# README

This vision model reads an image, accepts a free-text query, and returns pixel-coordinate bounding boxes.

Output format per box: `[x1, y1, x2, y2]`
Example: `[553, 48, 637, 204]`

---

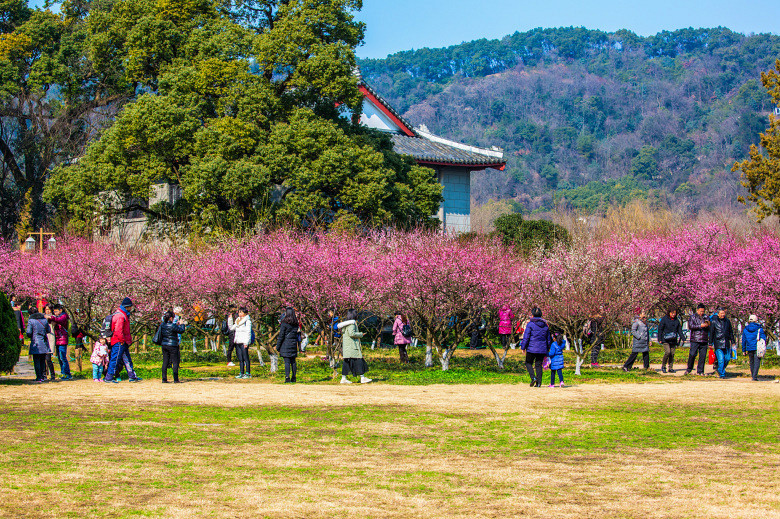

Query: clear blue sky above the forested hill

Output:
[357, 0, 780, 58]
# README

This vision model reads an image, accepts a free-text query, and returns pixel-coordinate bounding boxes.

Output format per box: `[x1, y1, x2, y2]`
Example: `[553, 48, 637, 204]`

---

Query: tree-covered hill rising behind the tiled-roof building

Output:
[360, 27, 780, 210]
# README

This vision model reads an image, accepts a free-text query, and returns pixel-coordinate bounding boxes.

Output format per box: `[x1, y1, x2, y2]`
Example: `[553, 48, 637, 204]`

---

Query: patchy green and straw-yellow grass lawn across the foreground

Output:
[0, 376, 780, 519]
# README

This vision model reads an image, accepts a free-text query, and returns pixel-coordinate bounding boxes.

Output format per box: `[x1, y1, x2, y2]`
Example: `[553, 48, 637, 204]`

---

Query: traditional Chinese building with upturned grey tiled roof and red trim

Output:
[360, 79, 506, 232]
